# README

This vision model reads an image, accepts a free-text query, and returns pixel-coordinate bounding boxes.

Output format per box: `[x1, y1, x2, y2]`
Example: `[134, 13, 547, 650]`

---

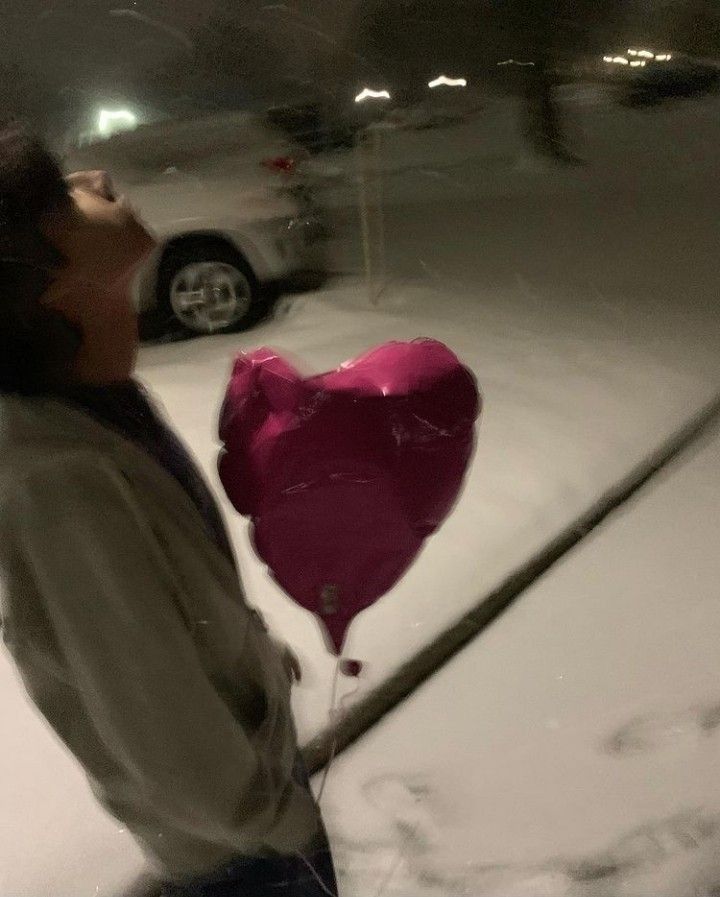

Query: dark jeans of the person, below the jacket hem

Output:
[162, 758, 337, 897]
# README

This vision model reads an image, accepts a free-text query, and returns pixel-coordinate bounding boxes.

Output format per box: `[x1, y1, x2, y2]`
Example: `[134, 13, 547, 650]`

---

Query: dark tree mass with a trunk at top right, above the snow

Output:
[353, 0, 720, 162]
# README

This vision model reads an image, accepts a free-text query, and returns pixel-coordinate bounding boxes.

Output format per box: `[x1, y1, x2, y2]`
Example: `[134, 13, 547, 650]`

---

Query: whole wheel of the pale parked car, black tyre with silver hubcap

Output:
[158, 240, 260, 335]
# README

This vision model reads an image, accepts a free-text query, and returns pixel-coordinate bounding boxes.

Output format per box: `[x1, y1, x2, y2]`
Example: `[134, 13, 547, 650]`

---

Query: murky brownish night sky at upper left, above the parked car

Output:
[0, 0, 362, 133]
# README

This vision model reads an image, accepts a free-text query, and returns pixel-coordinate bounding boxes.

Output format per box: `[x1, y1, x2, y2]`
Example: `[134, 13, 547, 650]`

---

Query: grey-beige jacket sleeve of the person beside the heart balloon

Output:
[7, 453, 317, 852]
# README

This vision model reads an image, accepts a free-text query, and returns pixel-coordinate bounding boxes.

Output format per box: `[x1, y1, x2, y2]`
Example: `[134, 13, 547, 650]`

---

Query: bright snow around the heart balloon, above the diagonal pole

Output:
[135, 260, 720, 740]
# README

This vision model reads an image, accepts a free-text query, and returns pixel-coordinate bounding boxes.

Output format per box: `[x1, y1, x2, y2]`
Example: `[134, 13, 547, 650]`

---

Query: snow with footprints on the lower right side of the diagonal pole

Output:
[322, 422, 720, 897]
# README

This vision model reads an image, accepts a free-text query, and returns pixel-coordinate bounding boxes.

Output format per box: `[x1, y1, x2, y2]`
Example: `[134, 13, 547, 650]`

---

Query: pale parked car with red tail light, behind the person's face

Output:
[65, 113, 326, 334]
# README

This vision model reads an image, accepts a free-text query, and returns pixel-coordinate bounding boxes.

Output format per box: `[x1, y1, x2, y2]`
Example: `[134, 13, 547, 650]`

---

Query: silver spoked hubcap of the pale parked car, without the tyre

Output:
[170, 262, 252, 333]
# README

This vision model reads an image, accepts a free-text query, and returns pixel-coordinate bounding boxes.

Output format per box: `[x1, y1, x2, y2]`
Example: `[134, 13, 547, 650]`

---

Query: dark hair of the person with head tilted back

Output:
[0, 124, 81, 395]
